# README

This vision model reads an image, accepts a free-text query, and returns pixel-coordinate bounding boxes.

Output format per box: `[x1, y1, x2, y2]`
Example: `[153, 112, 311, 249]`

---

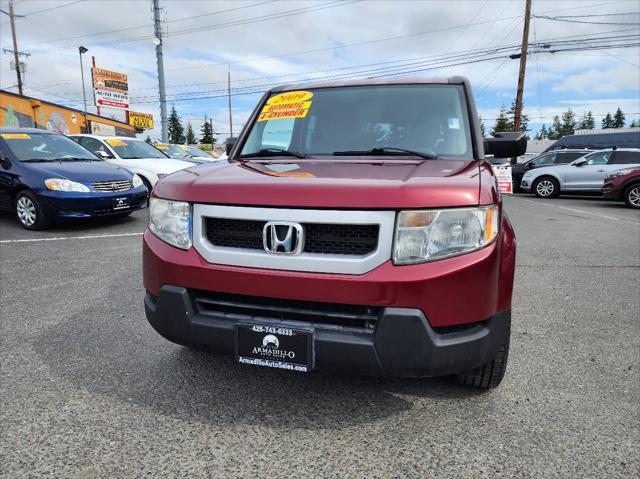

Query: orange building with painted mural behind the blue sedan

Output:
[0, 90, 144, 137]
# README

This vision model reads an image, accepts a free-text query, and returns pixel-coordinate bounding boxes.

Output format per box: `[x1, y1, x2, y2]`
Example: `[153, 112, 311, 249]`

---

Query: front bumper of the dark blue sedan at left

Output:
[38, 187, 148, 220]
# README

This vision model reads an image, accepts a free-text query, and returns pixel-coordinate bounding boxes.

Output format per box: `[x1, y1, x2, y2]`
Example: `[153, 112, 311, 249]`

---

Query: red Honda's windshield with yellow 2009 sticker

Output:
[240, 85, 473, 159]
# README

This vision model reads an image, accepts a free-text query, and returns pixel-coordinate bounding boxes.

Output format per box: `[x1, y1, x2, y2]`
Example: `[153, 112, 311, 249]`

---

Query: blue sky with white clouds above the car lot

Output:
[0, 0, 640, 137]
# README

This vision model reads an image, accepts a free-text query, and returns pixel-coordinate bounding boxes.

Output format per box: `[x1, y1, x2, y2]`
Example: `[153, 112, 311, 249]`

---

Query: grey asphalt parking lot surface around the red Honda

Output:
[0, 195, 640, 478]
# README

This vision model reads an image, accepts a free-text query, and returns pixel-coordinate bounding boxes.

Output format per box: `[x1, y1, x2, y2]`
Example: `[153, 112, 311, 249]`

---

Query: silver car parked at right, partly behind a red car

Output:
[520, 148, 640, 198]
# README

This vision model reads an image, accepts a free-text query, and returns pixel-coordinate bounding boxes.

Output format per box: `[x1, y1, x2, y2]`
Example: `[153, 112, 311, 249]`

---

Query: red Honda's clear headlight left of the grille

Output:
[149, 198, 191, 249]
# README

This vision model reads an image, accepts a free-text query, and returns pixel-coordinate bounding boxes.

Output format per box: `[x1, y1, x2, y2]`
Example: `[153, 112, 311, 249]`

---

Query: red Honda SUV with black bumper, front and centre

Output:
[144, 77, 526, 388]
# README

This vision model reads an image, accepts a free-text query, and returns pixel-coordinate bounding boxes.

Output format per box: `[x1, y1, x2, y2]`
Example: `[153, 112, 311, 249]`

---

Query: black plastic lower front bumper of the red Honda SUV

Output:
[145, 285, 511, 377]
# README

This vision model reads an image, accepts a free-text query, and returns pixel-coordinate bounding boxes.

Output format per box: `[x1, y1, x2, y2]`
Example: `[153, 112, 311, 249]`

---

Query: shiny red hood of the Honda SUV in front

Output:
[153, 158, 480, 209]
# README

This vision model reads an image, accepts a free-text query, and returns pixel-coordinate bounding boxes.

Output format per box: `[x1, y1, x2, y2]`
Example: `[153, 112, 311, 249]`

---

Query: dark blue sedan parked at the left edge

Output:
[0, 128, 148, 230]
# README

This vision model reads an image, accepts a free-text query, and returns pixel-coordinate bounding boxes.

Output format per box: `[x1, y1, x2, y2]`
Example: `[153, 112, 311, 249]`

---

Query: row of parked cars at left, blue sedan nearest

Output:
[0, 128, 202, 230]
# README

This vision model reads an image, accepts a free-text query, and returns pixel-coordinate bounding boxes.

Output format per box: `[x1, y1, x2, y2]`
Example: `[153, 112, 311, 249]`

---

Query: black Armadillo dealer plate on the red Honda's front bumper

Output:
[236, 324, 313, 372]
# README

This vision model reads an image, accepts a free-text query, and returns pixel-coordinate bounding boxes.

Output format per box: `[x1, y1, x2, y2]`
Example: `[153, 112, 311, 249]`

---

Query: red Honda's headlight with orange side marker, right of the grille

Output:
[393, 205, 498, 264]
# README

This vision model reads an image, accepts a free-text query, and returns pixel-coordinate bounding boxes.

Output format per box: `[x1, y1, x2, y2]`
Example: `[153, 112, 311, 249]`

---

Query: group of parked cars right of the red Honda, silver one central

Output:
[512, 148, 640, 208]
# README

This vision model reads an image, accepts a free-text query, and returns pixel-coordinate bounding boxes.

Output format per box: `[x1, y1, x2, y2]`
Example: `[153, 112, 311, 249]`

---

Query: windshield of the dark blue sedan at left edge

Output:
[1, 133, 102, 161]
